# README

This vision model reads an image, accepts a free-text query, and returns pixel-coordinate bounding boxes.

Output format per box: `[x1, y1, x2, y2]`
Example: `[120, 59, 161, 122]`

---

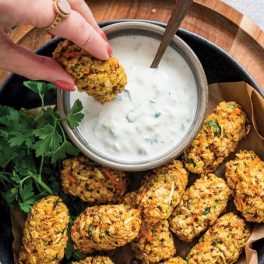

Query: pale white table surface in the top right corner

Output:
[223, 0, 264, 30]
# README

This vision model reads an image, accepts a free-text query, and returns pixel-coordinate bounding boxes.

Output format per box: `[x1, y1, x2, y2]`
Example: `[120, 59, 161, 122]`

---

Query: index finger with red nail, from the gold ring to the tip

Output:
[52, 10, 112, 60]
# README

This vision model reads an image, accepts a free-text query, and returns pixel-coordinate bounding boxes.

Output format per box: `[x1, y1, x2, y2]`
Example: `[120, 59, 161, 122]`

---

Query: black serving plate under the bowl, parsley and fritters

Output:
[0, 21, 264, 264]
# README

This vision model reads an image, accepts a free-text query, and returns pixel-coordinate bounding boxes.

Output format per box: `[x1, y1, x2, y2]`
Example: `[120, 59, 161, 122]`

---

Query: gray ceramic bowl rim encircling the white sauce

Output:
[57, 22, 208, 171]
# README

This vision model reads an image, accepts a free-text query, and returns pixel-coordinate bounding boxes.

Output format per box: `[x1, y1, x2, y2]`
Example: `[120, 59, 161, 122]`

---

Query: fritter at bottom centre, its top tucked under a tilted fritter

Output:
[131, 220, 176, 264]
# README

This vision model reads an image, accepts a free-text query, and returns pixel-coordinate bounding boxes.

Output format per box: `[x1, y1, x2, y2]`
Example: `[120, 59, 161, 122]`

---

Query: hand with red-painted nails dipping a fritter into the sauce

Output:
[0, 0, 112, 91]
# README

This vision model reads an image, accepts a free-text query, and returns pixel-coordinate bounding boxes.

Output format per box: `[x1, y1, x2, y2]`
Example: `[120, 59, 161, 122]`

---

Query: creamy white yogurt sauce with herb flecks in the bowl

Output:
[70, 36, 197, 162]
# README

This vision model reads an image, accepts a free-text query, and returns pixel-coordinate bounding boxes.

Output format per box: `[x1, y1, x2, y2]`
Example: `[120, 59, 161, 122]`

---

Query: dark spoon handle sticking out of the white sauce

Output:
[150, 0, 192, 68]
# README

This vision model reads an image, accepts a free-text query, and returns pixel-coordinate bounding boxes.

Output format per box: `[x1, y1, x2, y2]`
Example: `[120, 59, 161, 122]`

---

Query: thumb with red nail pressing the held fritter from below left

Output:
[0, 33, 74, 91]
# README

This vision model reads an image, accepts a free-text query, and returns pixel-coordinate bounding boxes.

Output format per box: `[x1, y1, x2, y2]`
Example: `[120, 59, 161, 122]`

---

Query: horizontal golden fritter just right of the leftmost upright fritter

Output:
[71, 204, 141, 253]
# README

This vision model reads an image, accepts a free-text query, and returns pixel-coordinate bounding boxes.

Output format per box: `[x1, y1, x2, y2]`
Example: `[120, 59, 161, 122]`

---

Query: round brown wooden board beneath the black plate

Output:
[0, 0, 264, 89]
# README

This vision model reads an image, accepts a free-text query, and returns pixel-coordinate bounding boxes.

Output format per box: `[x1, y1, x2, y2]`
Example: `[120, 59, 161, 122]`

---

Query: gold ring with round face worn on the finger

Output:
[46, 0, 71, 33]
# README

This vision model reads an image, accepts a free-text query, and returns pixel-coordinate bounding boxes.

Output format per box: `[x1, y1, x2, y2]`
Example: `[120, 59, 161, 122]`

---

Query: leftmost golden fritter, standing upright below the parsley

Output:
[19, 195, 69, 264]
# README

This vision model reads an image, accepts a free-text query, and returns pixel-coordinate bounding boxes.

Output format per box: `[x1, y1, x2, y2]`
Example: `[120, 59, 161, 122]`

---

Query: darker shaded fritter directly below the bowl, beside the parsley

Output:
[61, 156, 127, 204]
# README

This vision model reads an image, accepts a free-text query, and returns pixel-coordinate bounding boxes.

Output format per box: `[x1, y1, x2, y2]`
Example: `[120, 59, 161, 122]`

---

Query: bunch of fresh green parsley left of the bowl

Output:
[0, 81, 83, 213]
